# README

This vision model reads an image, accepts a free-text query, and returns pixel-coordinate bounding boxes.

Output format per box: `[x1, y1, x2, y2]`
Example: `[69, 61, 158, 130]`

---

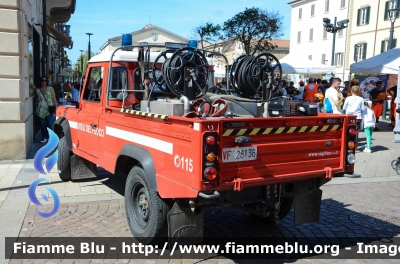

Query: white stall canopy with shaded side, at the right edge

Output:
[350, 48, 400, 74]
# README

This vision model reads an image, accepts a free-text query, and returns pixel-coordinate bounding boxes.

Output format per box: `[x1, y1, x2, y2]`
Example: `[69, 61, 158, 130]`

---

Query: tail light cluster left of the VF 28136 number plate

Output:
[202, 132, 218, 182]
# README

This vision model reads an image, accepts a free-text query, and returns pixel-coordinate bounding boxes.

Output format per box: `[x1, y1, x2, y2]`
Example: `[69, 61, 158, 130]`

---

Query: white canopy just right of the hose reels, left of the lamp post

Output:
[279, 54, 336, 74]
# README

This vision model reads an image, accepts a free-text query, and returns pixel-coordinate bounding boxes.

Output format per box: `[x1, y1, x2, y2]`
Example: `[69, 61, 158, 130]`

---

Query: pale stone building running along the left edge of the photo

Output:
[0, 0, 76, 160]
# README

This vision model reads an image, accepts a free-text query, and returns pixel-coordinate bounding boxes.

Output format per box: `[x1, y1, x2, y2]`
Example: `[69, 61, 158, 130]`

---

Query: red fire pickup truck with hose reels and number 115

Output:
[54, 40, 356, 244]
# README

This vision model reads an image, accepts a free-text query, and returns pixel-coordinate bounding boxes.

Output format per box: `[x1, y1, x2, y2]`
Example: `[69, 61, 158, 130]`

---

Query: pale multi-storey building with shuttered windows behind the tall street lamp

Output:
[288, 0, 400, 80]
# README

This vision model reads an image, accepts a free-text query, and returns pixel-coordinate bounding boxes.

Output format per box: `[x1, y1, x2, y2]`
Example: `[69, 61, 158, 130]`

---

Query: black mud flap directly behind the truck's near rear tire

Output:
[168, 203, 204, 247]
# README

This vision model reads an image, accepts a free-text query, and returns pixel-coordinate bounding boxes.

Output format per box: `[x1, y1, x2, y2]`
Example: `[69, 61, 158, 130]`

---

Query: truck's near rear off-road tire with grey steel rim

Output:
[125, 167, 170, 245]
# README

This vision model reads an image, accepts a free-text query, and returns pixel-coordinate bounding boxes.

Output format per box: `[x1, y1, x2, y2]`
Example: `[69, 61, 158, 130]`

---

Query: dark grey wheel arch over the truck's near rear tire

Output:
[114, 144, 158, 191]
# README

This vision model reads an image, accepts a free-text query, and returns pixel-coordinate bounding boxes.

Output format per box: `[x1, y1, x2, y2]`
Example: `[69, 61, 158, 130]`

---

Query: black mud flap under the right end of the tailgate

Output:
[294, 189, 322, 225]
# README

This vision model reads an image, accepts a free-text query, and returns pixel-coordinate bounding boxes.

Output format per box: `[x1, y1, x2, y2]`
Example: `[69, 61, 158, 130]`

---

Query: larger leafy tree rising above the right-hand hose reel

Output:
[222, 7, 283, 55]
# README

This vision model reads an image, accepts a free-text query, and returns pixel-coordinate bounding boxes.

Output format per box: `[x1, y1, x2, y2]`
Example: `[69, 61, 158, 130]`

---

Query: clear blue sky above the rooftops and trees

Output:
[67, 0, 291, 64]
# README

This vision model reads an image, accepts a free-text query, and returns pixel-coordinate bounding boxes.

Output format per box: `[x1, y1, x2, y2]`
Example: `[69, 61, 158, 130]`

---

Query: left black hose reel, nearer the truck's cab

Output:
[152, 47, 209, 98]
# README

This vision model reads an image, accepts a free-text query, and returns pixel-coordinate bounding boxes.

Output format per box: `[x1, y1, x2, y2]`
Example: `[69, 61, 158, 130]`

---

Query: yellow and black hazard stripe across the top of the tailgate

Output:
[222, 125, 342, 137]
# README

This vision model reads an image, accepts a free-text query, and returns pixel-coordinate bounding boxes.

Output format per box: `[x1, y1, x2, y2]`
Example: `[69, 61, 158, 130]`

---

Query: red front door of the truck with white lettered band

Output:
[78, 66, 104, 158]
